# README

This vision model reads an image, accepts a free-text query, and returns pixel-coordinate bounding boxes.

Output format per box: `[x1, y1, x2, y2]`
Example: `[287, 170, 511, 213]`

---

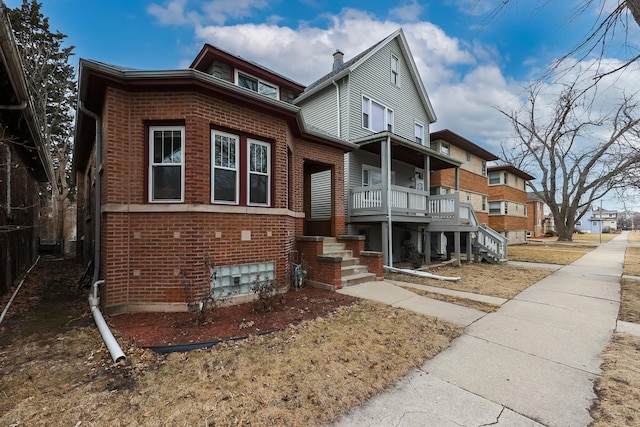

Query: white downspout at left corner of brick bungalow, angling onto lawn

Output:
[78, 101, 126, 363]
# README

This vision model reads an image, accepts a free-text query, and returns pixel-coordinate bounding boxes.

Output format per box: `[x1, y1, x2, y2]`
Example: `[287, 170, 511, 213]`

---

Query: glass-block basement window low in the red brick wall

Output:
[211, 261, 276, 298]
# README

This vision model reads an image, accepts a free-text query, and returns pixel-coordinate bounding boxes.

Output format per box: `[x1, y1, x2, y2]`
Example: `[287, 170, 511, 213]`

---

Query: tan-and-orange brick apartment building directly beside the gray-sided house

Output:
[430, 129, 498, 225]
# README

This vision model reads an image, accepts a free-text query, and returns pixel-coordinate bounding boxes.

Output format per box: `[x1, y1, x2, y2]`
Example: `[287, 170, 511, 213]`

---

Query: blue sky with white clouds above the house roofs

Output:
[4, 0, 640, 207]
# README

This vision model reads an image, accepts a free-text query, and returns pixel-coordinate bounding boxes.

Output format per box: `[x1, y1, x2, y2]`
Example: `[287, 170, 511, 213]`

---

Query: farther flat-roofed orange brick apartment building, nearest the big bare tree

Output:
[487, 165, 535, 244]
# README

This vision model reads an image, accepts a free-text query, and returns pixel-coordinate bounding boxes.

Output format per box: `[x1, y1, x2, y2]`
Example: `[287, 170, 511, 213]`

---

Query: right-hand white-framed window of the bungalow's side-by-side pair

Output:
[247, 139, 271, 206]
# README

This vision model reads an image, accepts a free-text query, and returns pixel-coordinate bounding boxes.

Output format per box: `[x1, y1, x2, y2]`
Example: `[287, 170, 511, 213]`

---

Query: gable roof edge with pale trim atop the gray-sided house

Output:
[293, 28, 436, 123]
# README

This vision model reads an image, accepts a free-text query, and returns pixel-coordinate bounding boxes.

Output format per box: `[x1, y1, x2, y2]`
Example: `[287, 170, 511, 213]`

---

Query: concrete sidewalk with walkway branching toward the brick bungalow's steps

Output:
[335, 233, 627, 427]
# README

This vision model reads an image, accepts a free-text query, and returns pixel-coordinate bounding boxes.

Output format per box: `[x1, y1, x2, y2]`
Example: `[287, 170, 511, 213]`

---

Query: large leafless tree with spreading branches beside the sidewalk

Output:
[498, 77, 640, 241]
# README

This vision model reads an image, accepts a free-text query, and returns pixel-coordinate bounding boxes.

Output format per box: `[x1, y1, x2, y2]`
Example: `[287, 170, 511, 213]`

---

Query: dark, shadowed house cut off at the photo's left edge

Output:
[0, 7, 54, 294]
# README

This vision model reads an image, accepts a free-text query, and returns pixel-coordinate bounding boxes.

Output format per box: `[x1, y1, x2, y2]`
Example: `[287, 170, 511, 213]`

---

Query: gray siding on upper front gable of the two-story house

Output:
[348, 40, 429, 142]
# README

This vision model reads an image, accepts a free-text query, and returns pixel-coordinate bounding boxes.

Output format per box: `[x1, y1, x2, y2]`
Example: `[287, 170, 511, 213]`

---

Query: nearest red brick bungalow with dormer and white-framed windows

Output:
[74, 45, 354, 313]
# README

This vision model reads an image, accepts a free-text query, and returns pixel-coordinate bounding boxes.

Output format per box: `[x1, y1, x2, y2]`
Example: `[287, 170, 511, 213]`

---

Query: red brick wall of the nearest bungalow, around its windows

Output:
[85, 88, 344, 311]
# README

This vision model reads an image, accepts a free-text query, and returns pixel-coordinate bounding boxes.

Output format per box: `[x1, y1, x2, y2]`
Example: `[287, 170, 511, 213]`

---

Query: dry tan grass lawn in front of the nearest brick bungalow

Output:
[0, 302, 462, 426]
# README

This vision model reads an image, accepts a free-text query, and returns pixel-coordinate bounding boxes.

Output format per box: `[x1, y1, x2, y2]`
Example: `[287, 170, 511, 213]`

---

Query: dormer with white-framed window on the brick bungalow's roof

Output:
[189, 44, 304, 104]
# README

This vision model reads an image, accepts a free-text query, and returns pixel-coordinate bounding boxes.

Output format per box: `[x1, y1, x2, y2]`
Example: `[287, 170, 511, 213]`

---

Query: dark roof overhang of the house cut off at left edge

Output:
[0, 7, 55, 186]
